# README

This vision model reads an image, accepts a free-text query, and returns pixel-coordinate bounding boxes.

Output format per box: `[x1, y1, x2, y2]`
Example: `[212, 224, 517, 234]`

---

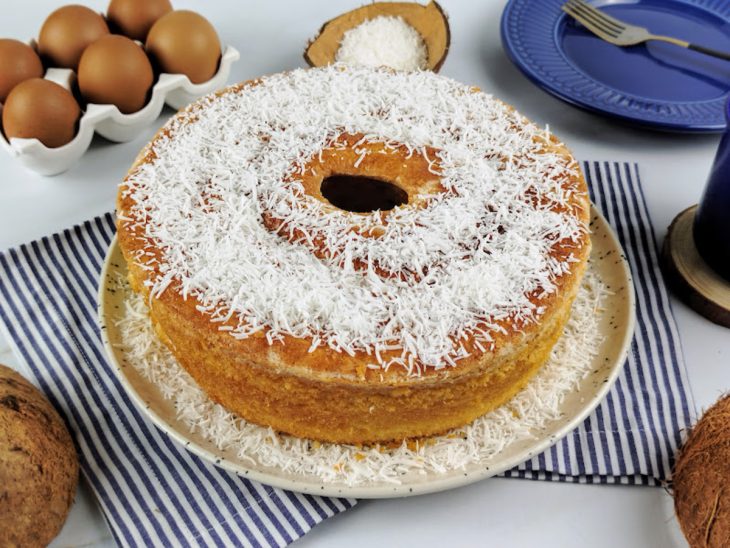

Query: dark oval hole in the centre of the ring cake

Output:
[320, 174, 408, 213]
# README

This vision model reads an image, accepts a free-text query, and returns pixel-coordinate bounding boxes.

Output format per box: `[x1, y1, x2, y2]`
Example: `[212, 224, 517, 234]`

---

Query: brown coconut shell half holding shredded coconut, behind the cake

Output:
[304, 2, 451, 72]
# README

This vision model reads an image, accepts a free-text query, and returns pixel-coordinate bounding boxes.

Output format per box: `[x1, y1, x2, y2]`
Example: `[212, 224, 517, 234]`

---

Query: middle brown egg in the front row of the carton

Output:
[78, 34, 154, 114]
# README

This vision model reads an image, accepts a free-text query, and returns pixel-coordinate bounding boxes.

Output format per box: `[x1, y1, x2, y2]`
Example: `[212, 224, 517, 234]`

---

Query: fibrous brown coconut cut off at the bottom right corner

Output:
[672, 395, 730, 548]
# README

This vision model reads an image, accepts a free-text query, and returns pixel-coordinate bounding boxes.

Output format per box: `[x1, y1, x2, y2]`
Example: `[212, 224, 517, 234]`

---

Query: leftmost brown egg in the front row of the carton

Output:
[3, 78, 81, 148]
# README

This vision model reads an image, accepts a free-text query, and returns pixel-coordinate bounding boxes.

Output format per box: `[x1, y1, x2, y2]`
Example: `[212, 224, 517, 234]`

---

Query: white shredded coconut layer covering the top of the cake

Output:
[122, 65, 587, 374]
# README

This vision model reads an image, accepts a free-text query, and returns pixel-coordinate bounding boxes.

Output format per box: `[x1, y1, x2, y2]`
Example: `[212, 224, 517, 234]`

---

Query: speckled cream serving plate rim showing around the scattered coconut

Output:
[99, 207, 635, 498]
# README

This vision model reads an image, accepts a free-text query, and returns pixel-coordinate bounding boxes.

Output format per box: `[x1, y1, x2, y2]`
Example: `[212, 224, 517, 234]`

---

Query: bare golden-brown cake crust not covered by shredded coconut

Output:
[117, 70, 590, 443]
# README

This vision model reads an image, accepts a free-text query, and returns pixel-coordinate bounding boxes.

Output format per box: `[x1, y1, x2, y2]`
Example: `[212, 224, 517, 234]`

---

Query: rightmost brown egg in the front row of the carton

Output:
[146, 10, 221, 84]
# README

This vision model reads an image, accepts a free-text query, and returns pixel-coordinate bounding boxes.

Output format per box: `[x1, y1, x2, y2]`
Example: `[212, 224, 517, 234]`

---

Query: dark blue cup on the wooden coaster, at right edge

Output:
[694, 100, 730, 281]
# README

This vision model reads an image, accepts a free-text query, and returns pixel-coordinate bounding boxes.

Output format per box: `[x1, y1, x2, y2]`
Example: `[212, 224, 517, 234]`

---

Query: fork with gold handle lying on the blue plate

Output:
[561, 0, 730, 61]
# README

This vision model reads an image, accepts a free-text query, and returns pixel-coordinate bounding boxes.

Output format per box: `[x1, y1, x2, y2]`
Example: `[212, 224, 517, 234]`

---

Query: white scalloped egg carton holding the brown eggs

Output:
[0, 46, 240, 175]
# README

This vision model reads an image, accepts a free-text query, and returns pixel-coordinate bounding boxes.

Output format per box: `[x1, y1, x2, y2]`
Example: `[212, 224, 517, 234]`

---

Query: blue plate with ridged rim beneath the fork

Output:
[501, 0, 730, 133]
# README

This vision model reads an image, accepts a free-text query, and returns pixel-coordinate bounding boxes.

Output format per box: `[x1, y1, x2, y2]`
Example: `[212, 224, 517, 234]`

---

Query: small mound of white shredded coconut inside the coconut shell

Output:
[335, 15, 428, 70]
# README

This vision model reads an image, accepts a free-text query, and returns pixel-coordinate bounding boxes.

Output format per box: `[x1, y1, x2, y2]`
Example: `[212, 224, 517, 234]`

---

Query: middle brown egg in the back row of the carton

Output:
[38, 5, 109, 69]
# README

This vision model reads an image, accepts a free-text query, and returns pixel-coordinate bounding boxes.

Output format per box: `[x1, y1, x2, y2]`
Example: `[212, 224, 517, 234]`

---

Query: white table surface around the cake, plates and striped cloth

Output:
[0, 0, 730, 548]
